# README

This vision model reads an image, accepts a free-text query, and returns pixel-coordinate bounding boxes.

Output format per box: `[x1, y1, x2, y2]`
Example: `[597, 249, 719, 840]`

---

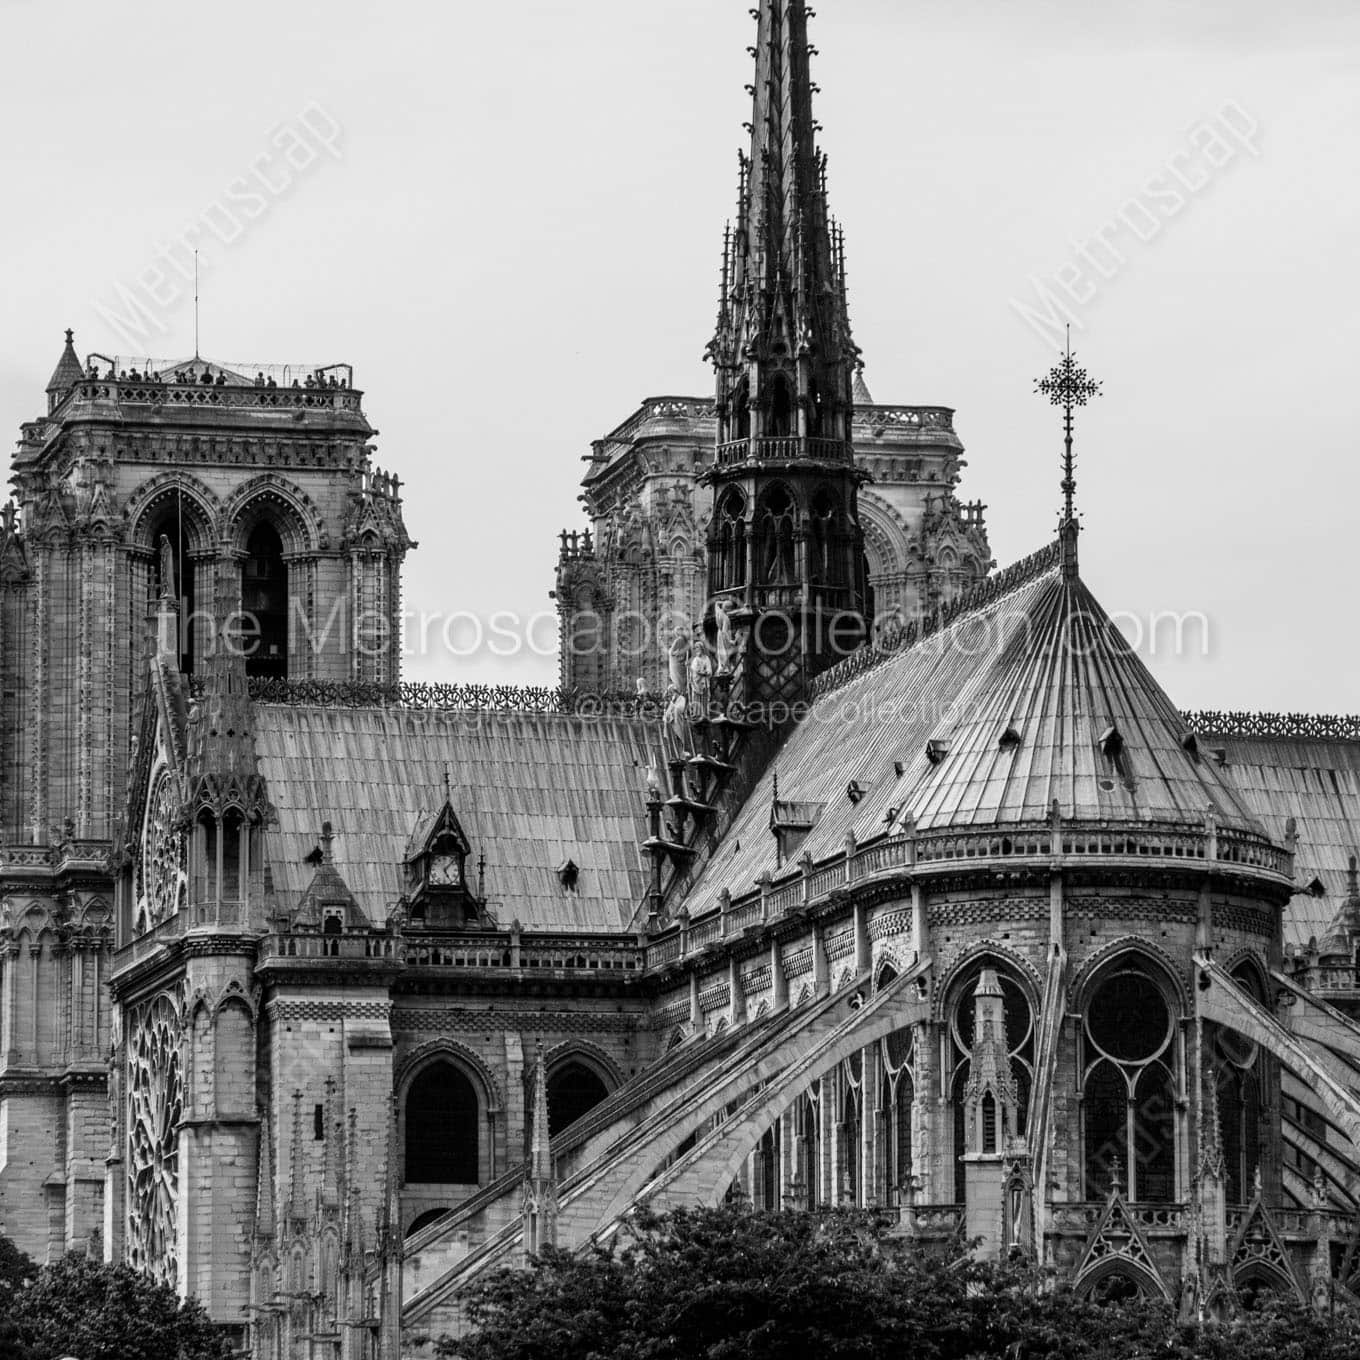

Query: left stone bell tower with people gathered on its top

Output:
[0, 330, 411, 1261]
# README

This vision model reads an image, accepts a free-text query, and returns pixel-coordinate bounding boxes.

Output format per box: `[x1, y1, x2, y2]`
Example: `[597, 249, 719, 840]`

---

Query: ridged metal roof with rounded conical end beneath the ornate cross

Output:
[690, 559, 1262, 914]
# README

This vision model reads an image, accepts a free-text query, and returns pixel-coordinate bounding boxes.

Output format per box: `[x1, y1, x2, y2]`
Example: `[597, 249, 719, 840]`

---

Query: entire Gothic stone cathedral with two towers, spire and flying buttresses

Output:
[0, 0, 1360, 1360]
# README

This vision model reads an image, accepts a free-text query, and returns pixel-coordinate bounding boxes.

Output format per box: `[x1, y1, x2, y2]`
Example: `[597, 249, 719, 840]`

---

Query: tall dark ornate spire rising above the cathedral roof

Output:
[706, 0, 866, 702]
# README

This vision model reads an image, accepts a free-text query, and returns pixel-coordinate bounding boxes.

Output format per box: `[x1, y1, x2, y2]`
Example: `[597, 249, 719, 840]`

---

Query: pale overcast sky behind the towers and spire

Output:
[0, 0, 1360, 711]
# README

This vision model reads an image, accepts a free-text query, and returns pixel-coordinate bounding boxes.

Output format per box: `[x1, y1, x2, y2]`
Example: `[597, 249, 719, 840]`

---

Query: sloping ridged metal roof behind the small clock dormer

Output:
[254, 704, 656, 932]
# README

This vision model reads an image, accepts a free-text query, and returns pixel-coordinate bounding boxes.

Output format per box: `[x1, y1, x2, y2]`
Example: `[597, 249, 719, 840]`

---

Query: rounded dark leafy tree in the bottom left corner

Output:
[9, 1251, 231, 1360]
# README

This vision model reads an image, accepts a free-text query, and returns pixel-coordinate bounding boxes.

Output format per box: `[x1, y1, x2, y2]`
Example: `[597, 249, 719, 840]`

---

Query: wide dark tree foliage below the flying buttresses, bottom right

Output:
[438, 1206, 1360, 1360]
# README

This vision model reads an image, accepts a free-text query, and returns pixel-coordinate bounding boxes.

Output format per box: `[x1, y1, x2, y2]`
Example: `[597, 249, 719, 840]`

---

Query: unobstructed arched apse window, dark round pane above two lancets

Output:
[1081, 964, 1175, 1204]
